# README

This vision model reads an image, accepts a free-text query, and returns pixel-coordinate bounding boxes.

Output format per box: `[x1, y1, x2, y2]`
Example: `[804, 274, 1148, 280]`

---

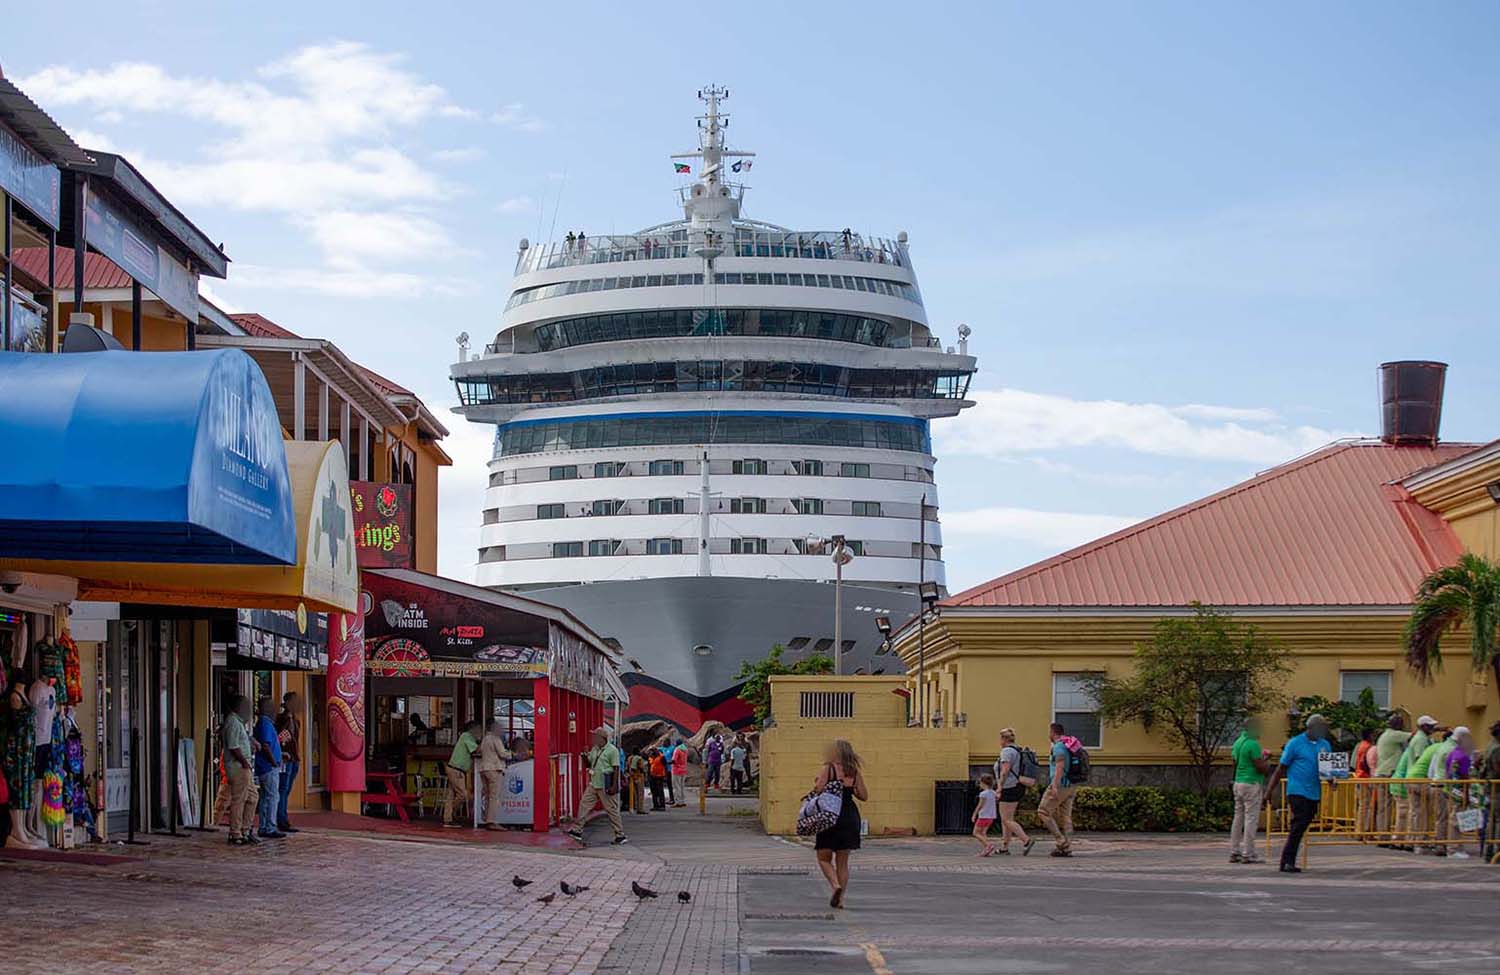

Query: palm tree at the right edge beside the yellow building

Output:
[1403, 552, 1500, 692]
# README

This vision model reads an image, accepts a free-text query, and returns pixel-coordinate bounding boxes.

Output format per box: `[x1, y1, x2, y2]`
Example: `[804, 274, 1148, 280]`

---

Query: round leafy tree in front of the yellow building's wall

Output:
[1086, 603, 1292, 795]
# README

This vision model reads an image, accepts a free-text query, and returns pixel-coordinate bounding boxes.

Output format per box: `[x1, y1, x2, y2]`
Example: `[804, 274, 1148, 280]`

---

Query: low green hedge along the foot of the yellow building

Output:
[1019, 786, 1235, 833]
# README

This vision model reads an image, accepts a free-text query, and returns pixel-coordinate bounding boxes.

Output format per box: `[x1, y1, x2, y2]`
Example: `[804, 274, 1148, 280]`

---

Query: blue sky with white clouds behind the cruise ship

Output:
[0, 0, 1500, 591]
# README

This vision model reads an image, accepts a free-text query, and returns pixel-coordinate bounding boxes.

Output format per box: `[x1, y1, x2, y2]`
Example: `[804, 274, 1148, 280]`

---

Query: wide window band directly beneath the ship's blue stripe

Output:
[495, 411, 932, 456]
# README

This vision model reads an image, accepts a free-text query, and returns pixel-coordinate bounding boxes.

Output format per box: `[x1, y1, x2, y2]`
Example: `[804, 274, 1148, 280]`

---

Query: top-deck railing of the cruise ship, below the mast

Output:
[516, 228, 906, 275]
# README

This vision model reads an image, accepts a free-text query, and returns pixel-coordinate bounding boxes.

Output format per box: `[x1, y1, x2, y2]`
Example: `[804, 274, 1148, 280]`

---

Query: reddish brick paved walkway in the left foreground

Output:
[0, 833, 663, 975]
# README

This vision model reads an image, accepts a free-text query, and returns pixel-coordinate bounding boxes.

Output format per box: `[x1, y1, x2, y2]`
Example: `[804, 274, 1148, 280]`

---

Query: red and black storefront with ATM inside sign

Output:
[357, 569, 627, 831]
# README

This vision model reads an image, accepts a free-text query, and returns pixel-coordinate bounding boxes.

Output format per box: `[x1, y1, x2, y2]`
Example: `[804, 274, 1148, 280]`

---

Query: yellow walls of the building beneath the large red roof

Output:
[897, 612, 1500, 780]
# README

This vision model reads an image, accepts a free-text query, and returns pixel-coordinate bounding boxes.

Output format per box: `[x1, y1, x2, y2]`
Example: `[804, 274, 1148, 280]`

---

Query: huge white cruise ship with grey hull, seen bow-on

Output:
[452, 87, 975, 734]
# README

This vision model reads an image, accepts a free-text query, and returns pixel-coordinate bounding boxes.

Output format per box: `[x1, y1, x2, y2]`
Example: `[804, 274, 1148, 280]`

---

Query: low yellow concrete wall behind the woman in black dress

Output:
[761, 677, 969, 836]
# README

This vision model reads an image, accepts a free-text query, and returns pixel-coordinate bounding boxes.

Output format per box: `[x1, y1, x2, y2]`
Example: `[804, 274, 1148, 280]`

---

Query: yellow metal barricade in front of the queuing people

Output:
[1265, 779, 1500, 866]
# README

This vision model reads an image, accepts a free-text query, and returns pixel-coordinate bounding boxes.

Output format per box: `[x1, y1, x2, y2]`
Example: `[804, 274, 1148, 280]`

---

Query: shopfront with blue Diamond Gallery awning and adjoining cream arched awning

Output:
[0, 343, 357, 831]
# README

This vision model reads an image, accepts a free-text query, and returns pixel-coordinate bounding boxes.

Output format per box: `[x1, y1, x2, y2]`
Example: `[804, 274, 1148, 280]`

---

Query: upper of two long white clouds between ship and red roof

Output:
[935, 389, 1358, 465]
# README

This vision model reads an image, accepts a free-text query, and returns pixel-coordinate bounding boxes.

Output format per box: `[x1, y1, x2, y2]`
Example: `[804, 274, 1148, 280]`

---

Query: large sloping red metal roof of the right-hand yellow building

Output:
[942, 441, 1476, 608]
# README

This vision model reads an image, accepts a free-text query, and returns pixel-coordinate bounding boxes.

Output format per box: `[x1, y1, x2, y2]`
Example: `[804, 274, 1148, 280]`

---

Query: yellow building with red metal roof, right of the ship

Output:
[896, 369, 1500, 785]
